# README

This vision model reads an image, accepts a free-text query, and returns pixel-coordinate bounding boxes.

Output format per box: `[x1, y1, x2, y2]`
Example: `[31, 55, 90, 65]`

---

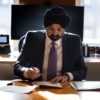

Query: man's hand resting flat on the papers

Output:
[50, 75, 69, 83]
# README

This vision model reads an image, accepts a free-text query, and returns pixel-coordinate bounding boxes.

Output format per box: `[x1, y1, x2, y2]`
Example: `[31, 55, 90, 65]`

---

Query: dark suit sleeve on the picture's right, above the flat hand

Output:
[71, 38, 87, 81]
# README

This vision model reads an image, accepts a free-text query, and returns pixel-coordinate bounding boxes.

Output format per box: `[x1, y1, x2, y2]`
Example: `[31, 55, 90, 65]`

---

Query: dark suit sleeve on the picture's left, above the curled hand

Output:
[14, 33, 30, 79]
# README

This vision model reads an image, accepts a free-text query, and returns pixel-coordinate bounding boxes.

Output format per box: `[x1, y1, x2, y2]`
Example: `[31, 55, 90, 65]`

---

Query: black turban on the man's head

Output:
[44, 6, 70, 28]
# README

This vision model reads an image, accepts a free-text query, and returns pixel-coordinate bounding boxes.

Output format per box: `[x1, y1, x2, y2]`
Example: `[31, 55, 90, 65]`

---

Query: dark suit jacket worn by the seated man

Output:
[14, 32, 87, 80]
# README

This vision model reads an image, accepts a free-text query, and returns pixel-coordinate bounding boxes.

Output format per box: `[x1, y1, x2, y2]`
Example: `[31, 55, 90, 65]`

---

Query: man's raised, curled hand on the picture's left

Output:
[27, 67, 41, 80]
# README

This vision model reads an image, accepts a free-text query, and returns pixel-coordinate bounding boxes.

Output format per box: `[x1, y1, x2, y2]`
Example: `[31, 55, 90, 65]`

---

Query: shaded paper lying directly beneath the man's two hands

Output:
[32, 81, 62, 88]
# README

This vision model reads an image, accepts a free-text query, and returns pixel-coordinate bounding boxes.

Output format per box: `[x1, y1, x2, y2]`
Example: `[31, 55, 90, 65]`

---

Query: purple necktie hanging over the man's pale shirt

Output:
[47, 42, 57, 80]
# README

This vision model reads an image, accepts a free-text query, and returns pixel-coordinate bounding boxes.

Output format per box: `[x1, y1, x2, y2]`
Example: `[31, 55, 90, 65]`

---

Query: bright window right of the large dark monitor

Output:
[84, 0, 100, 44]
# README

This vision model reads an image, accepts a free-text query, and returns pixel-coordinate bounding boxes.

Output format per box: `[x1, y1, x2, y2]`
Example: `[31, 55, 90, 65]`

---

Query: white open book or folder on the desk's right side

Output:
[69, 81, 100, 91]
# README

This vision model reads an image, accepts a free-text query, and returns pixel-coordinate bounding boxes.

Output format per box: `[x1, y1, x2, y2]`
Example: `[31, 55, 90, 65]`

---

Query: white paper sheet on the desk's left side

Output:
[0, 85, 37, 93]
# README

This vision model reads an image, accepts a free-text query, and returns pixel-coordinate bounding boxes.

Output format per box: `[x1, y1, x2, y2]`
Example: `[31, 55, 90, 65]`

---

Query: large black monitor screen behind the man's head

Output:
[11, 5, 84, 40]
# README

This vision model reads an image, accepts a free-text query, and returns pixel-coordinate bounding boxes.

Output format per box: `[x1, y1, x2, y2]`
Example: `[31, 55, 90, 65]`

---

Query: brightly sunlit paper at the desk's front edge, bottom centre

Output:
[38, 91, 80, 100]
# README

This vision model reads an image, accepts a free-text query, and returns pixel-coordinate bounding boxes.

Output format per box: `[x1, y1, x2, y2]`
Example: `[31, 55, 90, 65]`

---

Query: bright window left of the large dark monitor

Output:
[0, 0, 13, 37]
